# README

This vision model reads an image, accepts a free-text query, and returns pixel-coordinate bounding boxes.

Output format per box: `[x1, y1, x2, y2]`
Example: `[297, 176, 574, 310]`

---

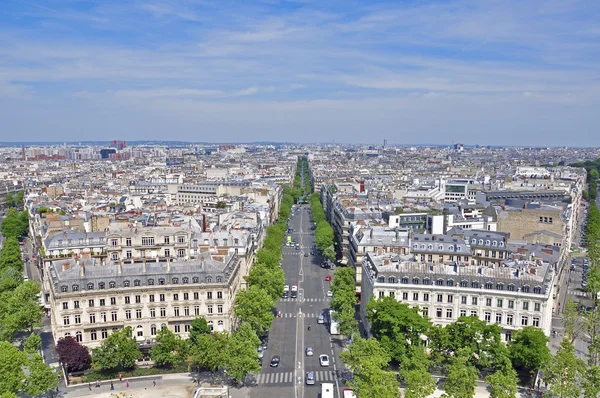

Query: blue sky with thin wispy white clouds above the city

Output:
[0, 0, 600, 146]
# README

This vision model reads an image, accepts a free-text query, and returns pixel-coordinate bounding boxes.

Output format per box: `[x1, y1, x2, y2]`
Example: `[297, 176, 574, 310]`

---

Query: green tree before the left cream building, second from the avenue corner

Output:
[190, 332, 230, 372]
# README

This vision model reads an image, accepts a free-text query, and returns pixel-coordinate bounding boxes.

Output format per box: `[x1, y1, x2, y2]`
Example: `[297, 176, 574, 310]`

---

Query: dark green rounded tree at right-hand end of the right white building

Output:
[508, 326, 550, 373]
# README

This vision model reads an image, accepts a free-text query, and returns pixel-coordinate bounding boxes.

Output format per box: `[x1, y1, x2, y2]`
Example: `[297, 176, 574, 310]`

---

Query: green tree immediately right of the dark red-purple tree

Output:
[92, 326, 142, 370]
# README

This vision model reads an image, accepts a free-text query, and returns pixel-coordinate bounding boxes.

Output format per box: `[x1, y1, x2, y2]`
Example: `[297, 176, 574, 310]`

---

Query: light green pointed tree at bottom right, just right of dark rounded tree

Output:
[544, 339, 585, 398]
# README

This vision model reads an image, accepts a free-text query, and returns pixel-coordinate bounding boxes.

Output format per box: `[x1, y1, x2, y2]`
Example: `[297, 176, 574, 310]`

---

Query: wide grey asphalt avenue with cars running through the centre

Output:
[250, 205, 341, 398]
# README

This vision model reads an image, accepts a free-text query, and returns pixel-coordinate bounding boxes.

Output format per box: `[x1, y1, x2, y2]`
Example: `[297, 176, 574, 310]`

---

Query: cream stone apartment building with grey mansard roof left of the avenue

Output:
[43, 253, 241, 348]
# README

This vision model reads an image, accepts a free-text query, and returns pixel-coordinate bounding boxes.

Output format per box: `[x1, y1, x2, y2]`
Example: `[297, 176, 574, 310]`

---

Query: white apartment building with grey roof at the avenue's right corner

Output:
[360, 253, 556, 341]
